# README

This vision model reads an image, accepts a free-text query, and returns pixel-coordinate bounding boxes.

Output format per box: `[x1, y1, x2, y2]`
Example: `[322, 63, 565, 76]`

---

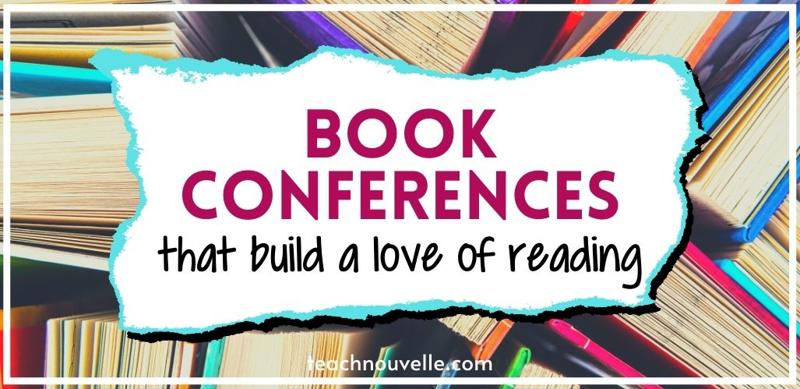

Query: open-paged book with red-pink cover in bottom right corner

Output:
[619, 244, 788, 377]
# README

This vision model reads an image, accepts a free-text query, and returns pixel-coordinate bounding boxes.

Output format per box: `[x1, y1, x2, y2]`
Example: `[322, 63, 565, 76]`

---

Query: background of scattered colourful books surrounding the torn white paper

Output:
[0, 0, 798, 384]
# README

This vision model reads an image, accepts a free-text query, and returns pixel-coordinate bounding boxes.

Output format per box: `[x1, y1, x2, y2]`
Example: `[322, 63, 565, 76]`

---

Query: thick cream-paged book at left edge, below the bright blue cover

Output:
[0, 94, 138, 270]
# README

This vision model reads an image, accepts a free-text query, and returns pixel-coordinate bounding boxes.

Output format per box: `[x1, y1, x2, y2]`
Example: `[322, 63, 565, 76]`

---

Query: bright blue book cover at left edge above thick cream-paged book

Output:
[0, 62, 111, 96]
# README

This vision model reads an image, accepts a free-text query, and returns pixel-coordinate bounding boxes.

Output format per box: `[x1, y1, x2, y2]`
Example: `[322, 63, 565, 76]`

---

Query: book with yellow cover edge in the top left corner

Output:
[2, 0, 262, 67]
